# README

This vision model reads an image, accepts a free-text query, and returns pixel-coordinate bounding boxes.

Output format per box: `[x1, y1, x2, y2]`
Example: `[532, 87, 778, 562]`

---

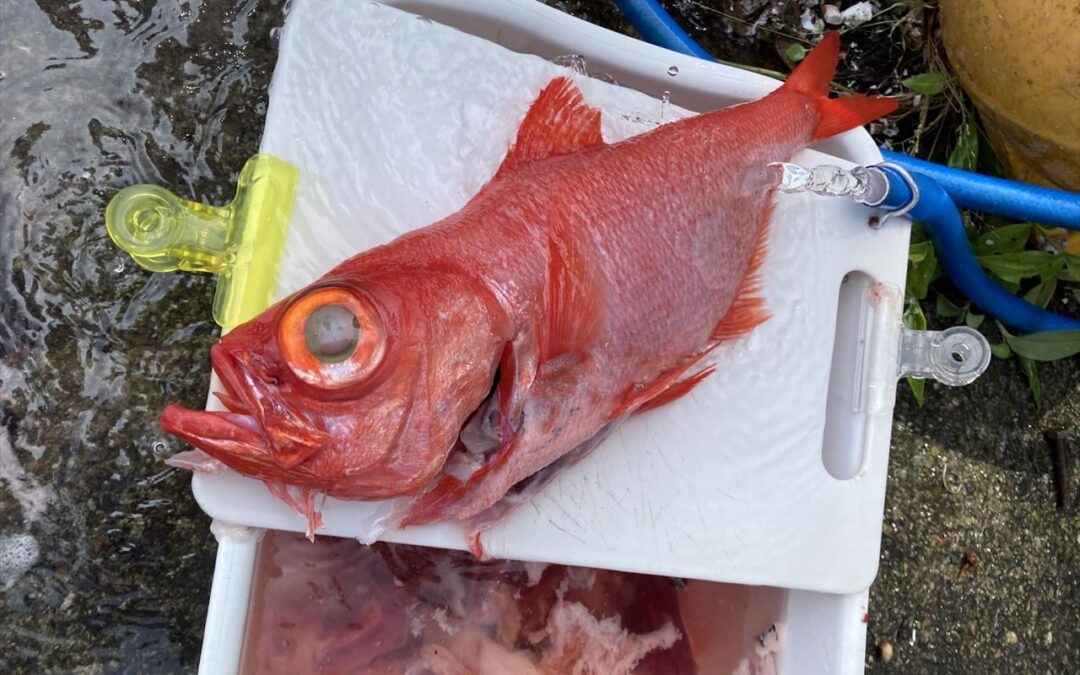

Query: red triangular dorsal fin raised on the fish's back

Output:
[499, 77, 604, 171]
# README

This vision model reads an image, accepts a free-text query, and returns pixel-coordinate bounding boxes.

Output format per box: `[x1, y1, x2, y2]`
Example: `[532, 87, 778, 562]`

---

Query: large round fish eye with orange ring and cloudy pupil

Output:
[278, 287, 387, 389]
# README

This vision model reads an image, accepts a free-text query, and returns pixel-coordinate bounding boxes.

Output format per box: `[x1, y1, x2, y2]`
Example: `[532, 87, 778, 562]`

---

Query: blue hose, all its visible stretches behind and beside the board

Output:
[616, 0, 1080, 333]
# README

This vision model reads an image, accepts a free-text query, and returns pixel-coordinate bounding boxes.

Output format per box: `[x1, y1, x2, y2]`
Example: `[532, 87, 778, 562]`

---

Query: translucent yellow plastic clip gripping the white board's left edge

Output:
[105, 154, 300, 330]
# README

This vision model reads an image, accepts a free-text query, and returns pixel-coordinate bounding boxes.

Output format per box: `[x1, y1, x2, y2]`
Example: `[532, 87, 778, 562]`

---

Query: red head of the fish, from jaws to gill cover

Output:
[162, 270, 505, 499]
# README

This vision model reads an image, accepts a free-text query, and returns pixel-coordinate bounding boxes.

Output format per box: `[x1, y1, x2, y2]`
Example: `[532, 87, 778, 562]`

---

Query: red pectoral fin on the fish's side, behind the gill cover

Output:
[539, 199, 600, 362]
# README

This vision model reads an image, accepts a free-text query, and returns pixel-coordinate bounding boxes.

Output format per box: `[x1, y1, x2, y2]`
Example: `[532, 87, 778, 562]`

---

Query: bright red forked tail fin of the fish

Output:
[783, 31, 896, 140]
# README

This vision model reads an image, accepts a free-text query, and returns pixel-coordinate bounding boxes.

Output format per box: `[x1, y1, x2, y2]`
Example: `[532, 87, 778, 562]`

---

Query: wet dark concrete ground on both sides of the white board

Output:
[0, 0, 1080, 673]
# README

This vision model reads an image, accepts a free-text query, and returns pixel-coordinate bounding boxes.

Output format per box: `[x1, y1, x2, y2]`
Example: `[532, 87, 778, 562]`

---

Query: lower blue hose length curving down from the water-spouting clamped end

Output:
[881, 166, 1080, 333]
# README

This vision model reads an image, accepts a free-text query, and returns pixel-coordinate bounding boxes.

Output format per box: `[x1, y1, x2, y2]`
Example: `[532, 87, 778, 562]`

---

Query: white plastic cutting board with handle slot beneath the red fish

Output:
[193, 0, 908, 593]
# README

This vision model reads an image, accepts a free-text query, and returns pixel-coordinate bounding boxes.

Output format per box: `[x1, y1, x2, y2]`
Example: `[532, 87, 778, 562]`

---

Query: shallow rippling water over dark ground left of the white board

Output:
[0, 0, 283, 673]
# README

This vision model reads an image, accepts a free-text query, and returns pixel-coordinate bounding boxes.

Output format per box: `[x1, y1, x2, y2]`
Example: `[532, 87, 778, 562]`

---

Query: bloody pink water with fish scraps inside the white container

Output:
[241, 531, 784, 675]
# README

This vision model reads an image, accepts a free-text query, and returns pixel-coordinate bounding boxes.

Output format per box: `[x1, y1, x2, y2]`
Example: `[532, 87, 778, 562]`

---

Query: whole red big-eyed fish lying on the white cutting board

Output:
[162, 33, 895, 552]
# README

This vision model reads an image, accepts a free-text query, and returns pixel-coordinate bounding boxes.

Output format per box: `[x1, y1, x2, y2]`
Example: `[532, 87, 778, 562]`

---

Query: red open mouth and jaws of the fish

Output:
[161, 345, 329, 474]
